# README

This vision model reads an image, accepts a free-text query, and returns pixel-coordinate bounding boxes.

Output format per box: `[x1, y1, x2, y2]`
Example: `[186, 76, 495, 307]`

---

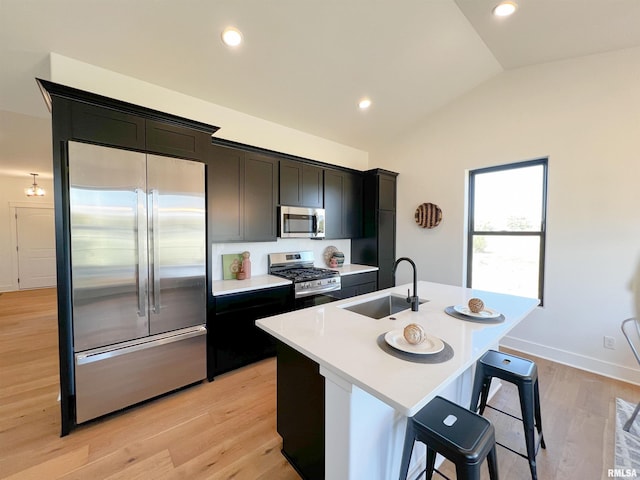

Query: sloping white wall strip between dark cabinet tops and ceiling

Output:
[49, 53, 369, 170]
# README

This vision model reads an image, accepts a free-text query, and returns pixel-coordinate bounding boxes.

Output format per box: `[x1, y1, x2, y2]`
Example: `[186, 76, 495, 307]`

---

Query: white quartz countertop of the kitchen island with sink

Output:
[256, 281, 538, 416]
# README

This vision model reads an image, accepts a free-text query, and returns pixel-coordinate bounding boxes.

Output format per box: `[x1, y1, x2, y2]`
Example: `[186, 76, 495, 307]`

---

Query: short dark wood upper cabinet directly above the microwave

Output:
[279, 160, 324, 208]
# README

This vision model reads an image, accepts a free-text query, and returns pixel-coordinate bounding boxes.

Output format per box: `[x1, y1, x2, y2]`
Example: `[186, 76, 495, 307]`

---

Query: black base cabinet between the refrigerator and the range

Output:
[207, 285, 293, 380]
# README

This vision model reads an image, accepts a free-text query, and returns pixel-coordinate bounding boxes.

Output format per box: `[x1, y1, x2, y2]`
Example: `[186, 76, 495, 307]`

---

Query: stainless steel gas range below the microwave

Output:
[269, 252, 341, 303]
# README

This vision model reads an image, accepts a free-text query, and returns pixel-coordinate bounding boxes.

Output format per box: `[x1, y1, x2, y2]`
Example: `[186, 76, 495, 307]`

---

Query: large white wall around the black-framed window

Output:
[370, 48, 640, 384]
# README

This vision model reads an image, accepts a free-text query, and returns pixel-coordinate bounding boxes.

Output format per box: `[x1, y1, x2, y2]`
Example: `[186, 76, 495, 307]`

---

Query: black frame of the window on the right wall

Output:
[466, 157, 549, 306]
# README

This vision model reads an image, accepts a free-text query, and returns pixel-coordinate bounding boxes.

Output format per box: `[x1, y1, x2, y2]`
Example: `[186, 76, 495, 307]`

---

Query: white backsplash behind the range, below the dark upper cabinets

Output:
[211, 238, 351, 280]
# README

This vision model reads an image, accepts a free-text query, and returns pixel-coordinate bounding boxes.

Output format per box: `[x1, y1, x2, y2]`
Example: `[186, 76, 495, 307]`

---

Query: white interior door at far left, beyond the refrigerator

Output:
[16, 207, 56, 290]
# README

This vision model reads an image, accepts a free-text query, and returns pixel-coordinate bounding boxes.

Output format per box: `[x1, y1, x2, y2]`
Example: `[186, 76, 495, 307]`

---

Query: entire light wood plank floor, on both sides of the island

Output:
[0, 289, 640, 480]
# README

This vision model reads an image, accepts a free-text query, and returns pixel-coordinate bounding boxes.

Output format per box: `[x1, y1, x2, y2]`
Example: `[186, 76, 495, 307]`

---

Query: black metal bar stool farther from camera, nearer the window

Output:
[470, 350, 547, 480]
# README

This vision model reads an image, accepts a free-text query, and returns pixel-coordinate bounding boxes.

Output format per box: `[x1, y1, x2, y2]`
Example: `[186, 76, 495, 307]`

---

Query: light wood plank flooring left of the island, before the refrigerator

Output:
[0, 289, 300, 480]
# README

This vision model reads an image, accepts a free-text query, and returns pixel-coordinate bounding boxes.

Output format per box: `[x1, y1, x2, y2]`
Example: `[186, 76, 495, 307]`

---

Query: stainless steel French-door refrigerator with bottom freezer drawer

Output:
[68, 142, 207, 423]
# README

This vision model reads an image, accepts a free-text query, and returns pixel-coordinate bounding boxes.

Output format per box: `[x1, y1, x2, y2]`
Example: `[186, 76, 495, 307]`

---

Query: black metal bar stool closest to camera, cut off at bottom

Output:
[399, 397, 498, 480]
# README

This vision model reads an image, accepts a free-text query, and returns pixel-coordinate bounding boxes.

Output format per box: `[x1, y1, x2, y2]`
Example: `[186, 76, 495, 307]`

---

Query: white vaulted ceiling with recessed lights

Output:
[0, 0, 640, 176]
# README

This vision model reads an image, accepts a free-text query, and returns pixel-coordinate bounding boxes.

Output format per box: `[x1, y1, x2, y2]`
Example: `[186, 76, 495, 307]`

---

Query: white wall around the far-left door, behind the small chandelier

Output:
[0, 175, 53, 292]
